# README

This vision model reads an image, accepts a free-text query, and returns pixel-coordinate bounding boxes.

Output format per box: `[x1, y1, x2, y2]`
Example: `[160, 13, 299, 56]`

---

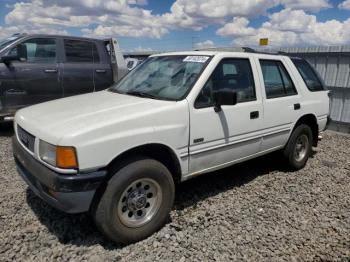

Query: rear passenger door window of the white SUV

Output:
[260, 60, 297, 98]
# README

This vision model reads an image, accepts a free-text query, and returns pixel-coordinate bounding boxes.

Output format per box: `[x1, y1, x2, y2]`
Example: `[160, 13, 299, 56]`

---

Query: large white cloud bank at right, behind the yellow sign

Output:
[217, 9, 350, 47]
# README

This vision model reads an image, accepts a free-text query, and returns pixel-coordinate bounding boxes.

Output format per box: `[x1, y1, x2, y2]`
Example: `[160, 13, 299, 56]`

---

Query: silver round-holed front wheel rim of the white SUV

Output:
[117, 178, 162, 228]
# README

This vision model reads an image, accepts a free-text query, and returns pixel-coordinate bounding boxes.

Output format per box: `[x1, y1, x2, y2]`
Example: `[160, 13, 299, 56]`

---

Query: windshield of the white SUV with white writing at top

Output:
[110, 56, 209, 100]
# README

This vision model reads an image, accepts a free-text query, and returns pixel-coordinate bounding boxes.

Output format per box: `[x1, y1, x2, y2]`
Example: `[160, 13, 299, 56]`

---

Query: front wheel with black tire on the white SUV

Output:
[94, 159, 175, 244]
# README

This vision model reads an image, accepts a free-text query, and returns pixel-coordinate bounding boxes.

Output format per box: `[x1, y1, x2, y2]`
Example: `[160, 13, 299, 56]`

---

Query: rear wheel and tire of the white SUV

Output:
[283, 124, 313, 170]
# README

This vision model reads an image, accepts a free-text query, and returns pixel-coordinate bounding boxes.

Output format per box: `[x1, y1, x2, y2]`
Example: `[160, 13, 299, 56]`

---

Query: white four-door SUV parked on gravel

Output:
[13, 51, 329, 243]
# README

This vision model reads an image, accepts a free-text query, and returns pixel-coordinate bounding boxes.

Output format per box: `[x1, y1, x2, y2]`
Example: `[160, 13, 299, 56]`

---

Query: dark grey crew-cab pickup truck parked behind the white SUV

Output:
[0, 34, 128, 122]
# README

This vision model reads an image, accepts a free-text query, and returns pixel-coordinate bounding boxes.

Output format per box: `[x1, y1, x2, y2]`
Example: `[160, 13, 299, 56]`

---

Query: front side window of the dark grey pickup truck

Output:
[10, 38, 56, 63]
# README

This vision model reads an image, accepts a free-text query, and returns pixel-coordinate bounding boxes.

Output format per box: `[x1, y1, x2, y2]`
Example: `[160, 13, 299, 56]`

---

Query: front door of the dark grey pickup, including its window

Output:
[1, 38, 62, 113]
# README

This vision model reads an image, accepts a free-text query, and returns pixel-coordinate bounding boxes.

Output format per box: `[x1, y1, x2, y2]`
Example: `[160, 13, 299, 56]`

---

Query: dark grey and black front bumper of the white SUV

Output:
[12, 136, 107, 213]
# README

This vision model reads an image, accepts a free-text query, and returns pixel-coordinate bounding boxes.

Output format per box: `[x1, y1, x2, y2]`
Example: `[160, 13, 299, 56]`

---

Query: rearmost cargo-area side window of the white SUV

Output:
[292, 59, 325, 91]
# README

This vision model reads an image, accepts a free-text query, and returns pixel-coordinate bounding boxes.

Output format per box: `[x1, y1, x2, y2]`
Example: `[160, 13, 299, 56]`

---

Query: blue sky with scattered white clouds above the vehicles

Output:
[0, 0, 350, 51]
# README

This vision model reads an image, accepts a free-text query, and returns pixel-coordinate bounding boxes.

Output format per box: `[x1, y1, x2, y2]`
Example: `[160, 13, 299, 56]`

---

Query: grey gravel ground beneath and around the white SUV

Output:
[0, 123, 350, 262]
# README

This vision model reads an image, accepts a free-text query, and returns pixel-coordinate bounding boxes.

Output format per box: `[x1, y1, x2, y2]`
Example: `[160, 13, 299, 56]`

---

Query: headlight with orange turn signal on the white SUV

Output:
[39, 140, 78, 169]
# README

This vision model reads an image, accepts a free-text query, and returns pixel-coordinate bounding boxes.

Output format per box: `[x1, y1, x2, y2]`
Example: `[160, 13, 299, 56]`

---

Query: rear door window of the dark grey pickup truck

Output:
[64, 39, 100, 63]
